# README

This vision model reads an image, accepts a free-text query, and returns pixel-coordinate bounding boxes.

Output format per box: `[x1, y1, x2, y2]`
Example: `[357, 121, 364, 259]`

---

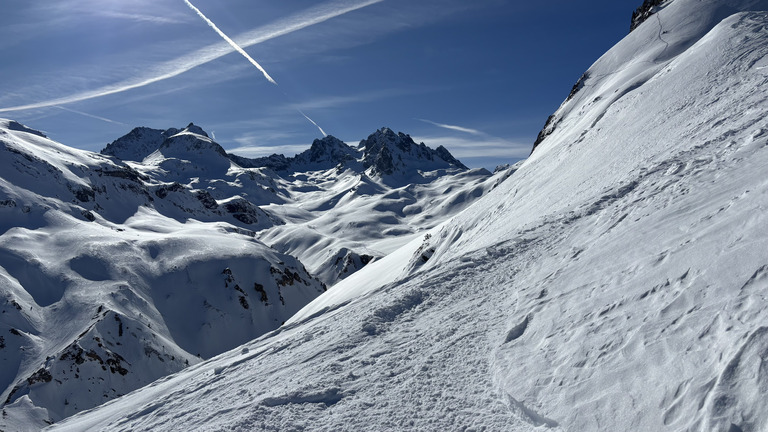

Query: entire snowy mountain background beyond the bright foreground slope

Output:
[0, 115, 496, 430]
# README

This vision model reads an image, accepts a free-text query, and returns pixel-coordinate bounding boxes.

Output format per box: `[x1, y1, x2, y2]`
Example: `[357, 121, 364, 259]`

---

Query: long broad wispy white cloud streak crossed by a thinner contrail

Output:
[0, 0, 384, 112]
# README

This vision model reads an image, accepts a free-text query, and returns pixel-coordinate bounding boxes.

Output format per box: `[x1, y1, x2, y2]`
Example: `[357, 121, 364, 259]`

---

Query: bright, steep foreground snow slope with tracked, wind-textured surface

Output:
[46, 0, 768, 431]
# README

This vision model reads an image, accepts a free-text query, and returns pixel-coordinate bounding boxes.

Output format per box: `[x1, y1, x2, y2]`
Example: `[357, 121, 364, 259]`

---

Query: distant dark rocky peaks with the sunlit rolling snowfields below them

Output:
[102, 124, 492, 285]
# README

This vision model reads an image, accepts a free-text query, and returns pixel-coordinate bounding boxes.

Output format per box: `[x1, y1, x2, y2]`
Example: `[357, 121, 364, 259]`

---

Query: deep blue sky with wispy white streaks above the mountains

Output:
[0, 0, 642, 168]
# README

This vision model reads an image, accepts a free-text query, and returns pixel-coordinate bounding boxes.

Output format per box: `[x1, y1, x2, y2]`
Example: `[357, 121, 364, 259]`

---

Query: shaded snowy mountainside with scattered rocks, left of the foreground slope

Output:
[0, 120, 324, 430]
